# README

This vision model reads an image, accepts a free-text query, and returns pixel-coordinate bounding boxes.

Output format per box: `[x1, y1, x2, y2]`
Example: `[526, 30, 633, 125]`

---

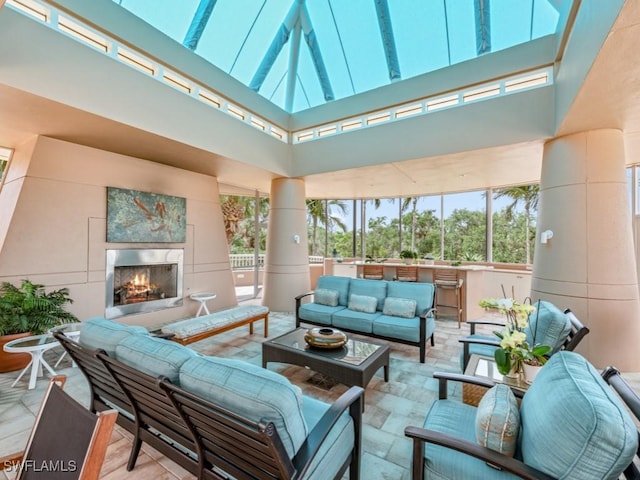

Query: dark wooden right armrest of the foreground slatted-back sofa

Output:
[293, 387, 364, 478]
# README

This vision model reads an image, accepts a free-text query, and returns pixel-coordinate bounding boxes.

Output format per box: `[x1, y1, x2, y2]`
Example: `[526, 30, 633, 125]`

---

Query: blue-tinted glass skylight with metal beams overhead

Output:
[113, 0, 559, 112]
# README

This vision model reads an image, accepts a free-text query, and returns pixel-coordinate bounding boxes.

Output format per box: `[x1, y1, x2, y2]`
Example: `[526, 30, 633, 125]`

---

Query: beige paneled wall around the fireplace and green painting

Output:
[0, 137, 236, 326]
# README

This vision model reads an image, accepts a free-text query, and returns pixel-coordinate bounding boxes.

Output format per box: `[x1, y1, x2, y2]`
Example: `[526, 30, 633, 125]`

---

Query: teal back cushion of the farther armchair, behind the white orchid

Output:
[525, 301, 571, 354]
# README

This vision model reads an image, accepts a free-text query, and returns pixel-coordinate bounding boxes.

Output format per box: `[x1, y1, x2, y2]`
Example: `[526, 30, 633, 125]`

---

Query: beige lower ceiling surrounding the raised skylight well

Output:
[0, 0, 640, 198]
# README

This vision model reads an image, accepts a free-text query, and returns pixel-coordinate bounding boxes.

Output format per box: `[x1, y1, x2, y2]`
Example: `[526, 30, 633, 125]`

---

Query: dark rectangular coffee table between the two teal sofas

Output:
[262, 327, 390, 396]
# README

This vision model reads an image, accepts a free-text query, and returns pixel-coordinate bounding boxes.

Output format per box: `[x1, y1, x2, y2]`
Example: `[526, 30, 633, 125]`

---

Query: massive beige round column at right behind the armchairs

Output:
[531, 129, 640, 372]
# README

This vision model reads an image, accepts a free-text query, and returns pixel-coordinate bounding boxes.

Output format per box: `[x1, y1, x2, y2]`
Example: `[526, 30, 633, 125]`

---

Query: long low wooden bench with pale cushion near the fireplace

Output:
[161, 305, 269, 345]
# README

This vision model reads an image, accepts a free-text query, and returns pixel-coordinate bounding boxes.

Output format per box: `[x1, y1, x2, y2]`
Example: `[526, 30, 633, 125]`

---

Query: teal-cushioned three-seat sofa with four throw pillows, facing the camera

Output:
[295, 275, 436, 363]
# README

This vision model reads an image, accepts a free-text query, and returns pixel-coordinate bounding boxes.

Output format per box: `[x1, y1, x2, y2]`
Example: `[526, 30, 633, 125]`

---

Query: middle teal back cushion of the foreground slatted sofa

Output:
[115, 335, 197, 385]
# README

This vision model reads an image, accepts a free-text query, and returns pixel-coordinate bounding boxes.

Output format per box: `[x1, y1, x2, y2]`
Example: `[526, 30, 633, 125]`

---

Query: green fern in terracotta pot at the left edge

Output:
[0, 280, 78, 372]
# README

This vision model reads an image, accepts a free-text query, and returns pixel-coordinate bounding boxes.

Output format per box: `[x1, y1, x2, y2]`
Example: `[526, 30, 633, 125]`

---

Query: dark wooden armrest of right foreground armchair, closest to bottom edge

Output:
[404, 426, 553, 480]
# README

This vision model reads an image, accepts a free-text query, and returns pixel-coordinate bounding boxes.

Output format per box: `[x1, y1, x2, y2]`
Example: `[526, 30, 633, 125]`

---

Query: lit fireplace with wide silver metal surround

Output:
[105, 248, 184, 318]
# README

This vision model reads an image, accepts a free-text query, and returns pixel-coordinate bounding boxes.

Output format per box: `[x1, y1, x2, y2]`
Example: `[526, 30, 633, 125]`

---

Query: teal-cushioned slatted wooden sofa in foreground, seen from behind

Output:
[54, 318, 363, 480]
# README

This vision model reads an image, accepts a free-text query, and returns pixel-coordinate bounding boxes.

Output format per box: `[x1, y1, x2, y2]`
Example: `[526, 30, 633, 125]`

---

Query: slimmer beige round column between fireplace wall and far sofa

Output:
[262, 178, 311, 312]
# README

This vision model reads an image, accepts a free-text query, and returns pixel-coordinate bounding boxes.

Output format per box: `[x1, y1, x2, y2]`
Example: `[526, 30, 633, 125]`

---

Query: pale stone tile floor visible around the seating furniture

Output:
[0, 312, 640, 480]
